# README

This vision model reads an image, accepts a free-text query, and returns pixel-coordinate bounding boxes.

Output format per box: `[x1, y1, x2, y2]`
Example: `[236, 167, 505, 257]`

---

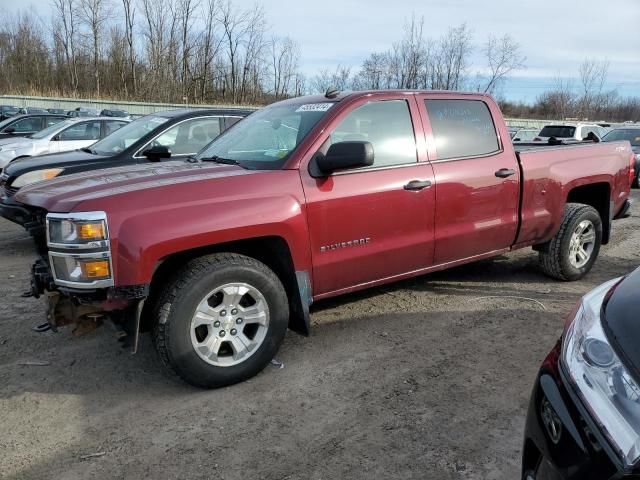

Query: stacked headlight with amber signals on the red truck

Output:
[47, 212, 113, 288]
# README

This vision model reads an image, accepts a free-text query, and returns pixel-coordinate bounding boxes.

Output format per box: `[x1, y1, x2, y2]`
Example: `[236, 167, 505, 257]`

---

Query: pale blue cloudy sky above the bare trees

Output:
[0, 0, 640, 101]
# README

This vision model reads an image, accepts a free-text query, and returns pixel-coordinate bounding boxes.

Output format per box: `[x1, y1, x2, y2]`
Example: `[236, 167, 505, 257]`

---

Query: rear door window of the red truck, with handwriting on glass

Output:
[425, 100, 500, 160]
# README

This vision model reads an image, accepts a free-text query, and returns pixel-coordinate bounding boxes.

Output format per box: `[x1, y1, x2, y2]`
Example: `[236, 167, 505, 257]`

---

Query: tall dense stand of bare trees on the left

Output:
[0, 0, 306, 104]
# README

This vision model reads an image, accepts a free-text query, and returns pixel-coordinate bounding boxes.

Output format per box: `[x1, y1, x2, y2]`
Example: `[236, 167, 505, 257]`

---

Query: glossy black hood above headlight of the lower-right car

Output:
[601, 268, 640, 379]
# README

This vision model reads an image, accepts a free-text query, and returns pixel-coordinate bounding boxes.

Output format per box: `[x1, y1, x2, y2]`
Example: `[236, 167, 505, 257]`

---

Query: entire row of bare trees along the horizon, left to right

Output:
[0, 0, 640, 121]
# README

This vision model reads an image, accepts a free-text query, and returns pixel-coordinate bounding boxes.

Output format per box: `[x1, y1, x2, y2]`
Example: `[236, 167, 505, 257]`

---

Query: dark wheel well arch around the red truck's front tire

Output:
[142, 236, 309, 335]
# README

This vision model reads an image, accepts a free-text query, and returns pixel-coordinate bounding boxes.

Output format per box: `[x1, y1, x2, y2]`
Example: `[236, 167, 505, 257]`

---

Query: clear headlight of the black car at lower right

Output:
[562, 279, 640, 466]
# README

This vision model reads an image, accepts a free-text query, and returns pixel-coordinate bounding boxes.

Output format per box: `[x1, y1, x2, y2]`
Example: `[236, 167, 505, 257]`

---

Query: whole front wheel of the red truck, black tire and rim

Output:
[154, 253, 289, 388]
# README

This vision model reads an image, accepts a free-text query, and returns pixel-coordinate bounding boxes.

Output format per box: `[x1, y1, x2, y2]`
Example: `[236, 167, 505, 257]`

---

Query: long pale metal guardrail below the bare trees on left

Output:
[0, 95, 257, 115]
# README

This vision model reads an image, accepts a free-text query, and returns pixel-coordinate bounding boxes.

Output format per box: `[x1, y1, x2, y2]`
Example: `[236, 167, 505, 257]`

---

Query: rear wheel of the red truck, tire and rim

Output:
[539, 203, 602, 281]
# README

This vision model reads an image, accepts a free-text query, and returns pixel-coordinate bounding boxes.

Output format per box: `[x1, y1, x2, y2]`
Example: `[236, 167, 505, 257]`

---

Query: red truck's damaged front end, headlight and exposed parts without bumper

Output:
[25, 212, 149, 353]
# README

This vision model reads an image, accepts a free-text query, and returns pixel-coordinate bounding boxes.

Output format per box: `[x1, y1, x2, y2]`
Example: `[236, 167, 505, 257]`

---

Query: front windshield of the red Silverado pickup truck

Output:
[196, 102, 335, 170]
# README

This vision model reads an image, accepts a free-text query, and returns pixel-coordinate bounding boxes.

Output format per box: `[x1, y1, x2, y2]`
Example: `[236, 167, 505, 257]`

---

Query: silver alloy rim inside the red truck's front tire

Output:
[190, 282, 269, 367]
